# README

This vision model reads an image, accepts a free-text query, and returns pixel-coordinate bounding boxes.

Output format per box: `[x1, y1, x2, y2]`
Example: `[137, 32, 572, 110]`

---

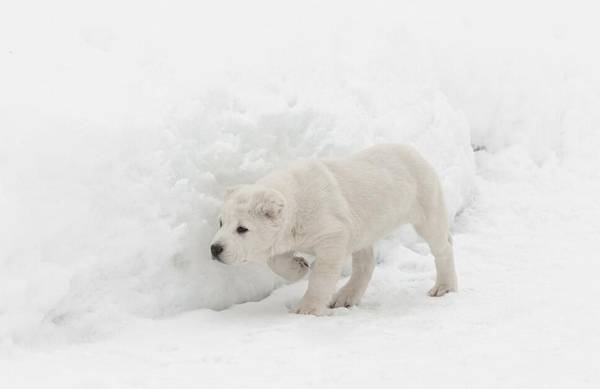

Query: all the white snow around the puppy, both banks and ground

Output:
[0, 1, 600, 388]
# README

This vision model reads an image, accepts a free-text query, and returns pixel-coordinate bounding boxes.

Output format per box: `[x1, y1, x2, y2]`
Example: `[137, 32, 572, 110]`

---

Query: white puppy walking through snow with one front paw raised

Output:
[211, 144, 457, 315]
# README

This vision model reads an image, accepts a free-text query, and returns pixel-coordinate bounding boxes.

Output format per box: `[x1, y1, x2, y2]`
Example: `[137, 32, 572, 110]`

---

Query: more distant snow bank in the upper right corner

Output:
[409, 1, 600, 165]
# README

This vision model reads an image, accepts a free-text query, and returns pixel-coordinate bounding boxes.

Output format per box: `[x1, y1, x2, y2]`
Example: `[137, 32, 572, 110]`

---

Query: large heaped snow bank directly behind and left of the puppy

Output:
[0, 2, 474, 343]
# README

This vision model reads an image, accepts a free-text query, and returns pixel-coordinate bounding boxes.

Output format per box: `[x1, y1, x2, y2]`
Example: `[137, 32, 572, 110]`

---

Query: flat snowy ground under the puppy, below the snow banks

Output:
[2, 148, 600, 388]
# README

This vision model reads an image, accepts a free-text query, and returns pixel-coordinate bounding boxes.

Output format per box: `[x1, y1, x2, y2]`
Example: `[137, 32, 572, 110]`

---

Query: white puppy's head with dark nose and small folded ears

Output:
[210, 185, 285, 264]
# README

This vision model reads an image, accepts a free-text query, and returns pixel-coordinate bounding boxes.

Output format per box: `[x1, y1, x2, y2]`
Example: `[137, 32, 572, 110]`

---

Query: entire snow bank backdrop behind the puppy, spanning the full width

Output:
[9, 0, 600, 343]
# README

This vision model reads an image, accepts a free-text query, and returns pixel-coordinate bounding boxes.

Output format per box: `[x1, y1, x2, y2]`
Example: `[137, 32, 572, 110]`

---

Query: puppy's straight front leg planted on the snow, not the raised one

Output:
[295, 249, 346, 315]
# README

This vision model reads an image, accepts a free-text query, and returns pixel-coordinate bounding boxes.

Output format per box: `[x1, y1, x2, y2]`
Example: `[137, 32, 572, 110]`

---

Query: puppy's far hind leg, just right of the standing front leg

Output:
[330, 247, 375, 308]
